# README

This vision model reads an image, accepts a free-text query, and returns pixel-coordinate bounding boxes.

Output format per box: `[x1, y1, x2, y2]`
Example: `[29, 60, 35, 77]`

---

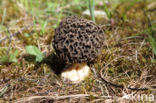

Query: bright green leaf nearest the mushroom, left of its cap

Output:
[25, 45, 44, 62]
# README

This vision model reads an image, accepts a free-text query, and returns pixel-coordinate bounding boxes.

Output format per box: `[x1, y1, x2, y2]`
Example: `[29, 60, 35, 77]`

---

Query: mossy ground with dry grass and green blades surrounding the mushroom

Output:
[0, 0, 156, 103]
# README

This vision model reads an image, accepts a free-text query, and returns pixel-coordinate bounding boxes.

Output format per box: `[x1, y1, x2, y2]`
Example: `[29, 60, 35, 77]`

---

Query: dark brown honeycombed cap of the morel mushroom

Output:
[52, 16, 104, 64]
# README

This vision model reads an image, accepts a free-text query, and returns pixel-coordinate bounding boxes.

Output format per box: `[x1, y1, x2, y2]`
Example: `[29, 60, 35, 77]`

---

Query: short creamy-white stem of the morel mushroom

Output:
[61, 63, 90, 83]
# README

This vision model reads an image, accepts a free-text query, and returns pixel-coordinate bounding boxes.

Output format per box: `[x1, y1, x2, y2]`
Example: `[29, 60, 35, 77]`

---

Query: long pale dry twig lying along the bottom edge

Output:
[15, 94, 112, 103]
